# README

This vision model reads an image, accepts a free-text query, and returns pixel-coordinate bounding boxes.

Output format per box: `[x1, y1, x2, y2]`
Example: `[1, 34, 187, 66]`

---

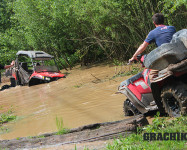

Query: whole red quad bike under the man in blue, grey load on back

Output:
[118, 29, 187, 117]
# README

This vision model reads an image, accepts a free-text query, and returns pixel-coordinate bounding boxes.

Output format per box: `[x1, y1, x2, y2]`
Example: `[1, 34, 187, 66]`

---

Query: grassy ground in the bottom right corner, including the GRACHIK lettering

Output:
[107, 116, 187, 150]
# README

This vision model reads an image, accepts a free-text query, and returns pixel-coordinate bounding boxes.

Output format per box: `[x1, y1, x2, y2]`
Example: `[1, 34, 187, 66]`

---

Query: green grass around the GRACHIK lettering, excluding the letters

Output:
[107, 116, 187, 150]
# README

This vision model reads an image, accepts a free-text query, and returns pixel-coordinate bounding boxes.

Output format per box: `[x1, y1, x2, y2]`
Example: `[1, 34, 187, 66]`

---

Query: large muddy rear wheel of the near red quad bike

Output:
[161, 82, 187, 117]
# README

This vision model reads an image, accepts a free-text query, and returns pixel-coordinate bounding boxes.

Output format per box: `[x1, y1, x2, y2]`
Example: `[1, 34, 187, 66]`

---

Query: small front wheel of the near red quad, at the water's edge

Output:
[123, 99, 140, 116]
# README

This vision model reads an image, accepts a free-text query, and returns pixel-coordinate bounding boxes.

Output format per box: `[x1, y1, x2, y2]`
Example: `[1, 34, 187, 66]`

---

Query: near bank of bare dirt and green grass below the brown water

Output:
[0, 115, 187, 150]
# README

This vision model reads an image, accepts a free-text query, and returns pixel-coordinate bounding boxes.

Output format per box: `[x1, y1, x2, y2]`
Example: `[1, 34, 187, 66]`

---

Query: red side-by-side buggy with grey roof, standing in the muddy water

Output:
[10, 51, 65, 87]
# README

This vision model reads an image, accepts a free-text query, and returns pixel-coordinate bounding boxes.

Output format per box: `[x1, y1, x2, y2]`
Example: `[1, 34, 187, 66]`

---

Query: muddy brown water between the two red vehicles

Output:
[0, 65, 134, 140]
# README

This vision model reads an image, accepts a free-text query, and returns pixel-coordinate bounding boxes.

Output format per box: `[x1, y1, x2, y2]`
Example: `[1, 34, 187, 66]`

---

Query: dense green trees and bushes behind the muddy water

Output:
[0, 0, 187, 68]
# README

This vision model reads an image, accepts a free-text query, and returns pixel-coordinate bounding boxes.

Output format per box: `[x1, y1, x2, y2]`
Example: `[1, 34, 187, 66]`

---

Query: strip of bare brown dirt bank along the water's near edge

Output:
[0, 115, 148, 150]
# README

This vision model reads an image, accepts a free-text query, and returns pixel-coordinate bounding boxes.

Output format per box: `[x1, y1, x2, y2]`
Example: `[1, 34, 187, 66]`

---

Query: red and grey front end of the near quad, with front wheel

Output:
[118, 57, 158, 116]
